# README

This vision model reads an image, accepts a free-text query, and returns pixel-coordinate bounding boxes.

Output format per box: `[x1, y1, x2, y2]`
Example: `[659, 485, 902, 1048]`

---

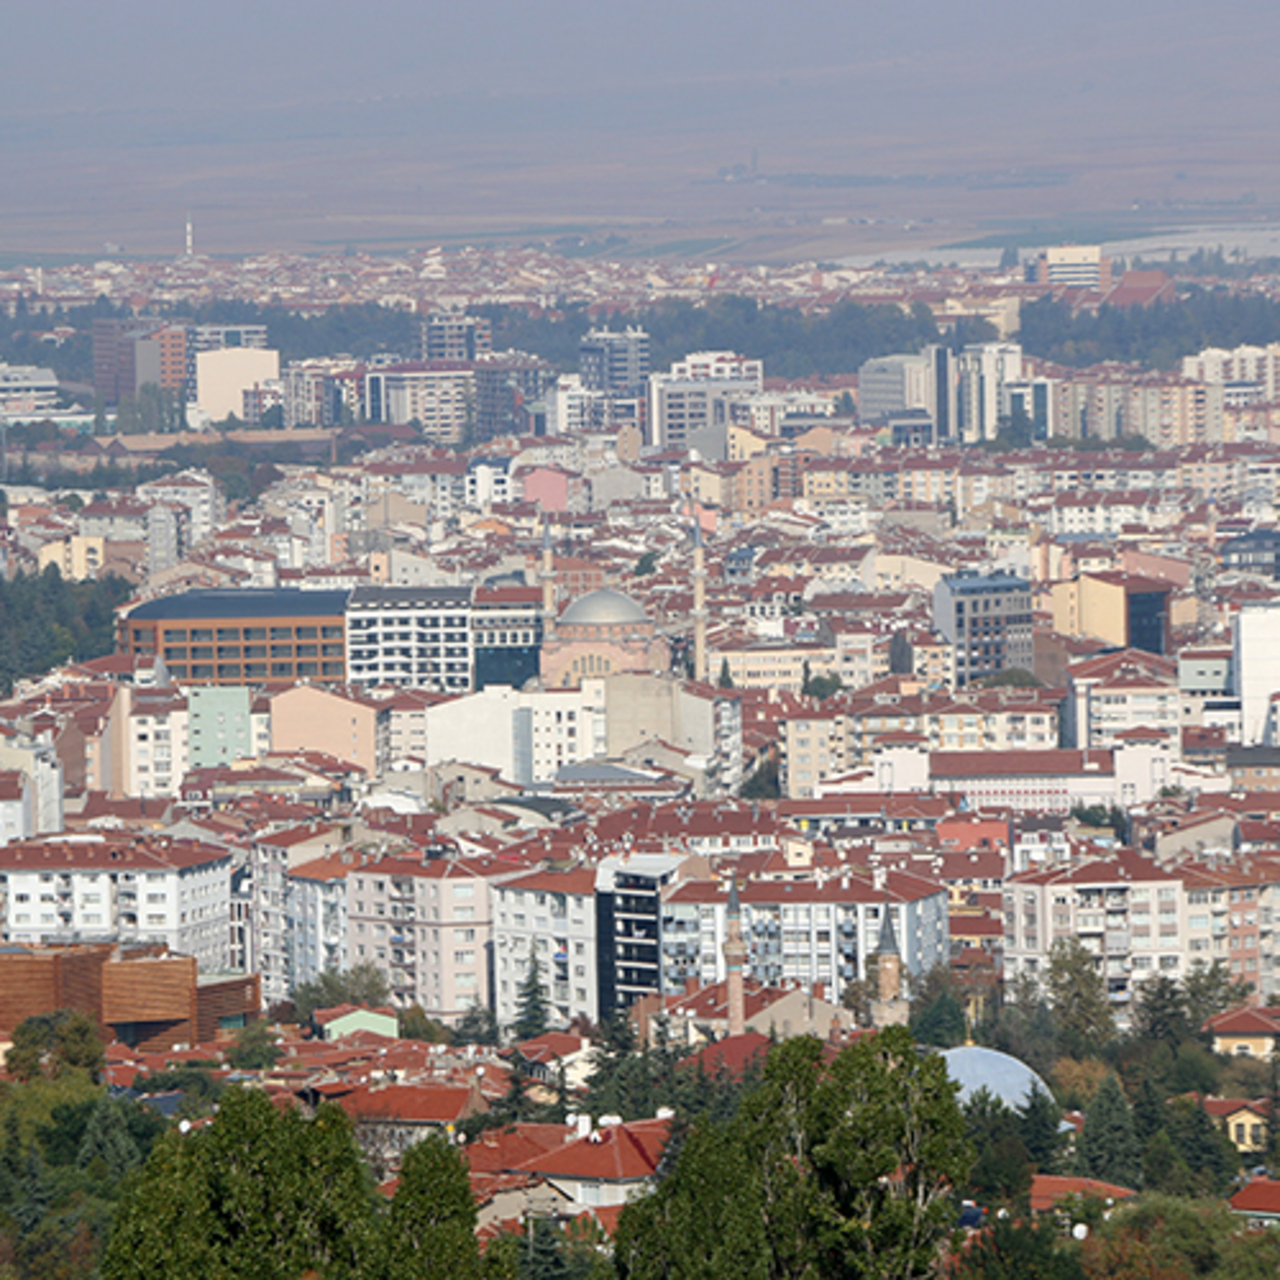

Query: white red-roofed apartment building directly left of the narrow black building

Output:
[494, 867, 600, 1027]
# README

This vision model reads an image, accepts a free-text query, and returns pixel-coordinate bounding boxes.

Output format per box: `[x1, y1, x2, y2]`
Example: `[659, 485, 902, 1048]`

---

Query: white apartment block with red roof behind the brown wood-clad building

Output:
[0, 835, 232, 972]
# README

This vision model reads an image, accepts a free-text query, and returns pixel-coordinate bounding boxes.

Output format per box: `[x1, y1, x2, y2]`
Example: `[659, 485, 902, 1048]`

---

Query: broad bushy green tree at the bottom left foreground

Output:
[101, 1089, 379, 1280]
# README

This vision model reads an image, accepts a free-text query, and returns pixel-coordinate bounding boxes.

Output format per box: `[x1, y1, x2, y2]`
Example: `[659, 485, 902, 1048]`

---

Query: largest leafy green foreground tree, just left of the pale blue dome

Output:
[614, 1027, 972, 1280]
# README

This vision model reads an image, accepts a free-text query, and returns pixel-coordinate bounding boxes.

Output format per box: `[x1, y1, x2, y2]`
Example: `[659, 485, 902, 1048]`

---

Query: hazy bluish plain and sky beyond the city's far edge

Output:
[10, 0, 1280, 260]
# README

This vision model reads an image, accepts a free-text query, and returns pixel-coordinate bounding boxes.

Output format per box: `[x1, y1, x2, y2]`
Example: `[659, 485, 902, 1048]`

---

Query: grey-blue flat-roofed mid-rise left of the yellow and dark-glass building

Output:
[933, 571, 1033, 687]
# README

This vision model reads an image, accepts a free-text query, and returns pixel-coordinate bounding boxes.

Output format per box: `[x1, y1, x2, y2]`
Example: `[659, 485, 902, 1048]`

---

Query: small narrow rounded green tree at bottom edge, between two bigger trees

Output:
[380, 1134, 481, 1280]
